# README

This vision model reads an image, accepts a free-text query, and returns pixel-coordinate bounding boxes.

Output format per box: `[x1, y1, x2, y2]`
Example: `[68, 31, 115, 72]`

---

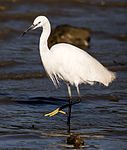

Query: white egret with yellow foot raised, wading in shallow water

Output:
[23, 16, 115, 133]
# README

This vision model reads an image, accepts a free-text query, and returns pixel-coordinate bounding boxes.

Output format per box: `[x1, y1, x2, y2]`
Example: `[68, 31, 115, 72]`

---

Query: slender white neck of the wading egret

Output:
[39, 19, 51, 52]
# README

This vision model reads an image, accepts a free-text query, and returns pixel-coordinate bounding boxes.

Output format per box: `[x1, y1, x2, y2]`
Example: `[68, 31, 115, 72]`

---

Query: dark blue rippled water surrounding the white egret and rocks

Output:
[0, 0, 127, 150]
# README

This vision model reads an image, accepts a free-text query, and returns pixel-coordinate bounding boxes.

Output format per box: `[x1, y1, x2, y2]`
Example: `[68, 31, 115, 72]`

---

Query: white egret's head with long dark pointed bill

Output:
[22, 16, 48, 36]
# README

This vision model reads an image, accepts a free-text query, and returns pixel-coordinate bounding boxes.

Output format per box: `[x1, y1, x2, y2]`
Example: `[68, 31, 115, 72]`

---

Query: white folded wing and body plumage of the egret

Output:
[51, 43, 115, 86]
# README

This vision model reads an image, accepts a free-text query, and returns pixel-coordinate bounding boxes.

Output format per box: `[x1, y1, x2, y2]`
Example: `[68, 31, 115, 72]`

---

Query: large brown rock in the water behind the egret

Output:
[48, 25, 90, 49]
